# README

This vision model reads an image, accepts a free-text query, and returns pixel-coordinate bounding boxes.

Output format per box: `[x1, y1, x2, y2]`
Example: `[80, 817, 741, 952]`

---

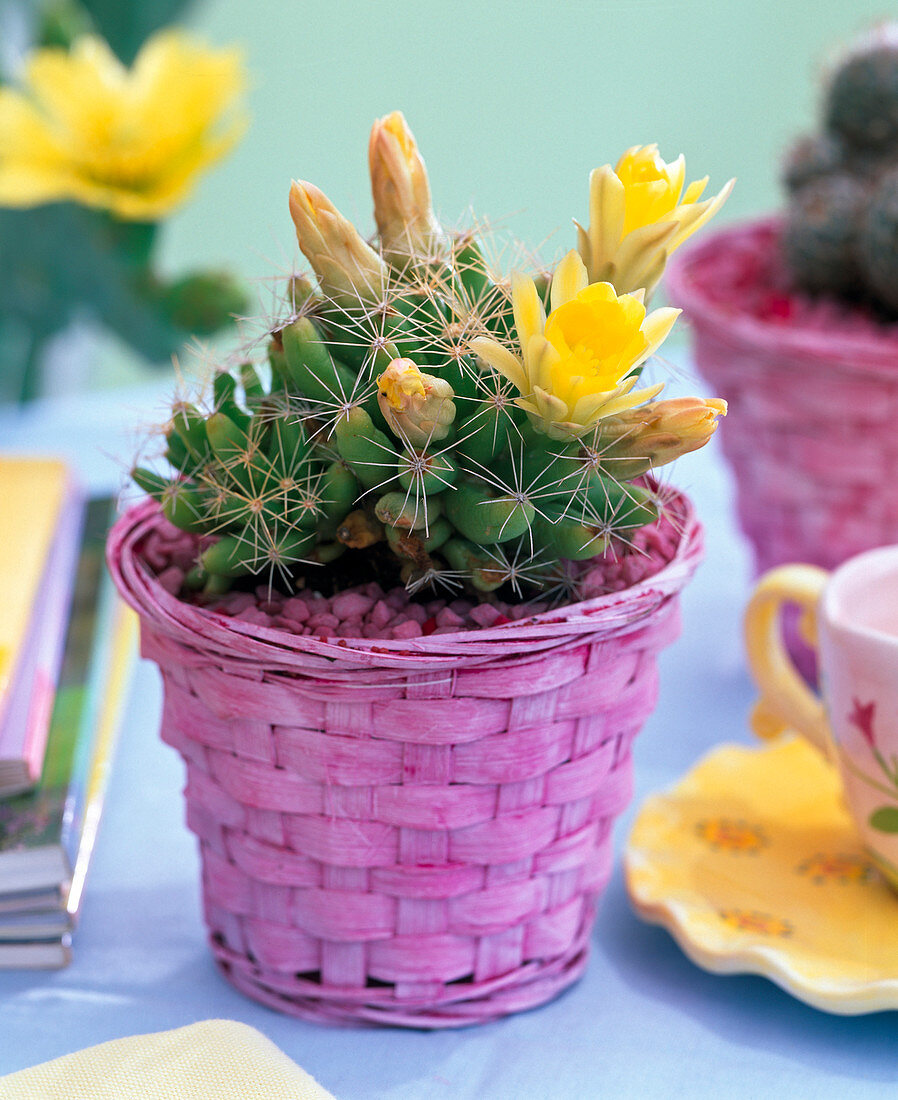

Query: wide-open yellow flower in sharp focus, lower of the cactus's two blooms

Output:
[470, 251, 680, 439]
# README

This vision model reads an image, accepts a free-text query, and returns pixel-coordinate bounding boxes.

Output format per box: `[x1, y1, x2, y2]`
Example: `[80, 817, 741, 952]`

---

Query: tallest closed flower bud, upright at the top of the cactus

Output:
[368, 111, 442, 266]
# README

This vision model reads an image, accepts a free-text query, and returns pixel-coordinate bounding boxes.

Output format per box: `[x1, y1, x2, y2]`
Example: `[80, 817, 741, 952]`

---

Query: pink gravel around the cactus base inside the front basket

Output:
[142, 506, 679, 639]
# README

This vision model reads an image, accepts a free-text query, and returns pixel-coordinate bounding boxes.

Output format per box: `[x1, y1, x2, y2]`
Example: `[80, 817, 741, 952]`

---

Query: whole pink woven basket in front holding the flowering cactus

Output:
[108, 494, 701, 1027]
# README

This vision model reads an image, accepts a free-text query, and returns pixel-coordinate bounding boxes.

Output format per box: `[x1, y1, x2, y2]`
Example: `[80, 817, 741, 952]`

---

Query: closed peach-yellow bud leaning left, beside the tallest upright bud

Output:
[289, 179, 386, 309]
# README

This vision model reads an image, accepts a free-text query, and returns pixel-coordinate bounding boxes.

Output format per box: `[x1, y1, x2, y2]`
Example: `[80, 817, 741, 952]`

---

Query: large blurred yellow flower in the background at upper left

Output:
[0, 31, 243, 221]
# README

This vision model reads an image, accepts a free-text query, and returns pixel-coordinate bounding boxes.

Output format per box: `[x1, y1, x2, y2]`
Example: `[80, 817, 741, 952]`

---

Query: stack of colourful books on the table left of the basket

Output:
[0, 458, 136, 968]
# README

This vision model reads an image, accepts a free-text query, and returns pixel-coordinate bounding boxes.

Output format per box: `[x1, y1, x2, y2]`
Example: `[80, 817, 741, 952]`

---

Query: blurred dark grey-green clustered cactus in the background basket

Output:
[782, 24, 898, 318]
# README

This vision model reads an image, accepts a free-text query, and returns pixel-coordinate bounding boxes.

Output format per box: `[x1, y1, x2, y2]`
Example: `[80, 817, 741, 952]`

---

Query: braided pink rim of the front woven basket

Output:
[107, 486, 703, 672]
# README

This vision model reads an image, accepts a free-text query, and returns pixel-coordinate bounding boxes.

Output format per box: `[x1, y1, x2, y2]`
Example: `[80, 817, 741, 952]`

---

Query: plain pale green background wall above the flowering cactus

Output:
[164, 0, 898, 299]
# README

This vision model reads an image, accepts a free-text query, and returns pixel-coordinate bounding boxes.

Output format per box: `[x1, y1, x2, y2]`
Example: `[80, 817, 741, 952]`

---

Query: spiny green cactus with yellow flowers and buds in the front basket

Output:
[134, 112, 725, 593]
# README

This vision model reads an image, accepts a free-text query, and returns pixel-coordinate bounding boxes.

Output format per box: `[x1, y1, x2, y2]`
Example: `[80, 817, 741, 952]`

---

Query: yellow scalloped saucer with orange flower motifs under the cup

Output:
[624, 734, 898, 1015]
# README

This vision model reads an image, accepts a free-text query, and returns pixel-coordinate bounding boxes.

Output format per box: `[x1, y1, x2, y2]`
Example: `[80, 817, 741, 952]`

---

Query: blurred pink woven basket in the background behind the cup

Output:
[666, 219, 898, 572]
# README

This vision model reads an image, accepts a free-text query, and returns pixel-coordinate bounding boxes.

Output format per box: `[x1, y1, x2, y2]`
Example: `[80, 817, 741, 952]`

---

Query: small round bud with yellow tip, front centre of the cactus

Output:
[377, 359, 456, 448]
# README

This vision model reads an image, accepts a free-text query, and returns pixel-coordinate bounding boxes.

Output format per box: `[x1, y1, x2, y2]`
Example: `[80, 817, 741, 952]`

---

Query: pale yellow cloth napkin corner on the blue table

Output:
[0, 1020, 335, 1100]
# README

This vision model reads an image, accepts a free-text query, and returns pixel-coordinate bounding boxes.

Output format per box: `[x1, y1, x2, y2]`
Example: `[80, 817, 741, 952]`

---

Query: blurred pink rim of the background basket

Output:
[665, 215, 898, 378]
